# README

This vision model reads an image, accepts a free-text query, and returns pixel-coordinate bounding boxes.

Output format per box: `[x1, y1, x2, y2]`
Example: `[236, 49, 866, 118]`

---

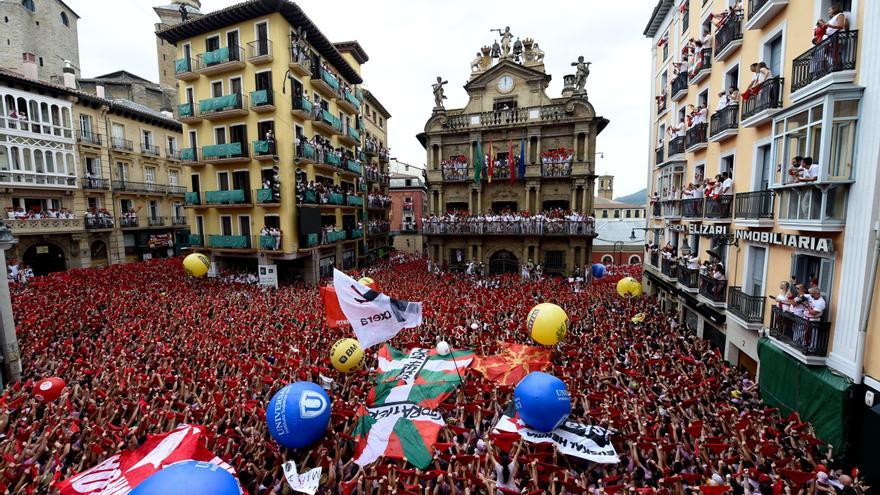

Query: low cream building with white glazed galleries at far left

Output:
[0, 71, 187, 274]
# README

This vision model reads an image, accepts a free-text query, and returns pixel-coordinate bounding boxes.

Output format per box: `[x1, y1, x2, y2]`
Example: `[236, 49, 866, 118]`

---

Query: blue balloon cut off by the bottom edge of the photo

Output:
[130, 461, 241, 495]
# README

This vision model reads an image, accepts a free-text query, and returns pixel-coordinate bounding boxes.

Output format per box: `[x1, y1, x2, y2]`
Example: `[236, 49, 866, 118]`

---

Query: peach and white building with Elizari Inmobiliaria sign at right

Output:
[645, 0, 880, 464]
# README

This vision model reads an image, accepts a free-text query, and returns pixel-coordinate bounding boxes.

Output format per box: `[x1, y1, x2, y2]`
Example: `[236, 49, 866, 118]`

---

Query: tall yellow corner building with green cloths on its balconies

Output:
[157, 0, 387, 281]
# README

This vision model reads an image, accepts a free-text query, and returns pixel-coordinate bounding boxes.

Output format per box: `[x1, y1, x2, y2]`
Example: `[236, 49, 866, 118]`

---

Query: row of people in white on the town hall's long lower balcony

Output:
[422, 209, 593, 235]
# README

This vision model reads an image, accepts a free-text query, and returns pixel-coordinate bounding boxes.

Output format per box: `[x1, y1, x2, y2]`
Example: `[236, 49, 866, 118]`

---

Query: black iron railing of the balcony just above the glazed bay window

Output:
[791, 31, 859, 93]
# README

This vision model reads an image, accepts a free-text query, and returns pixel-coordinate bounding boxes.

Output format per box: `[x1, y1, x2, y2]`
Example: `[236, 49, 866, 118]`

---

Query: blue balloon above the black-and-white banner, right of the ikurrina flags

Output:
[513, 371, 571, 433]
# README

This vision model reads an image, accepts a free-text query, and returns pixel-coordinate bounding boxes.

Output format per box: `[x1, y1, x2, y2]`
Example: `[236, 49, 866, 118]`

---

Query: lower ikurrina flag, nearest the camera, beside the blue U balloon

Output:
[353, 402, 444, 469]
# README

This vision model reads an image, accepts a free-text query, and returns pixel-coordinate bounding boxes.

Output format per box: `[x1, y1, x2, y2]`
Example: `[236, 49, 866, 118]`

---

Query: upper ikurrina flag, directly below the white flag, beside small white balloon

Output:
[367, 344, 474, 409]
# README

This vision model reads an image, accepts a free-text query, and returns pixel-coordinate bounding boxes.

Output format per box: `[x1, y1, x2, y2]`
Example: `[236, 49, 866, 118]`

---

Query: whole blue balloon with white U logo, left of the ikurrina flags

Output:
[266, 382, 330, 449]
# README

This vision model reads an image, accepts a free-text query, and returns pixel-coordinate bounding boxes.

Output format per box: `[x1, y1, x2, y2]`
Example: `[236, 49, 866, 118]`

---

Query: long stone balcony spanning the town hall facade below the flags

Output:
[422, 220, 595, 237]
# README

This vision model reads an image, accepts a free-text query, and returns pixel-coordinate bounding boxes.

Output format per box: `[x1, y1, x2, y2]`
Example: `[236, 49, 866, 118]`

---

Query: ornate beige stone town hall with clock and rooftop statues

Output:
[419, 32, 608, 273]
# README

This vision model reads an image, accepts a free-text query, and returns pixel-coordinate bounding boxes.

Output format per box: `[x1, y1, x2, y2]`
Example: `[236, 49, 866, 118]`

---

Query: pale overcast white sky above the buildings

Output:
[66, 0, 655, 196]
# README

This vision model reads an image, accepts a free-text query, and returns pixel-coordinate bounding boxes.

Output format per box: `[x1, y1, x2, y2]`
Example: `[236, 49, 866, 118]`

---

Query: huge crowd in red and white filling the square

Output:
[0, 257, 863, 495]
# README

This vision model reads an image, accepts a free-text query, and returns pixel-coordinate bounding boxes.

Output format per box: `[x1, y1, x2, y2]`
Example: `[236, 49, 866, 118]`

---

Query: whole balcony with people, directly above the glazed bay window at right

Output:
[791, 31, 859, 101]
